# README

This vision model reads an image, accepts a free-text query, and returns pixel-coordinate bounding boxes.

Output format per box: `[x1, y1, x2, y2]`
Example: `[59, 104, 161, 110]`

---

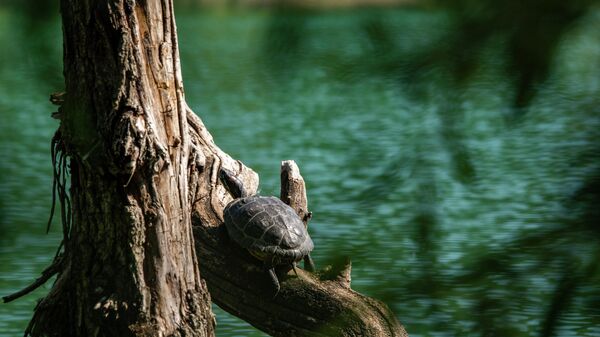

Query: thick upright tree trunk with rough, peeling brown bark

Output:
[22, 0, 214, 336]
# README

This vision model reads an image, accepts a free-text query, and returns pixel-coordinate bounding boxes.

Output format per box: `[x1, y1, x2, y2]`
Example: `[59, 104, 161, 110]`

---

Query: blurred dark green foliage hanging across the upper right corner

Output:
[350, 0, 593, 109]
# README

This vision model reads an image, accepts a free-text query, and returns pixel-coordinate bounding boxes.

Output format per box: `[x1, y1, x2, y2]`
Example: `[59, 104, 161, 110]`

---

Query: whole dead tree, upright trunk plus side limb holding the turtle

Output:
[5, 0, 408, 337]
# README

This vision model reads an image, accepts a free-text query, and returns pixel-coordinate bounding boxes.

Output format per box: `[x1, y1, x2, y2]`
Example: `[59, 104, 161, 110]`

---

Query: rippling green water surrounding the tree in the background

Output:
[0, 2, 600, 337]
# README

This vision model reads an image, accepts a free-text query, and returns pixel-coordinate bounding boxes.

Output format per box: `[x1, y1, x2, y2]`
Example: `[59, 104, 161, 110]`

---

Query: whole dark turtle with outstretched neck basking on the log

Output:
[219, 169, 315, 296]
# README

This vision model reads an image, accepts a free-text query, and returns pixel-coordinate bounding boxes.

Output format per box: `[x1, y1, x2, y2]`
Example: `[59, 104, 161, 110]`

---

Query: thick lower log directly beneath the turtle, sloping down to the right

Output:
[194, 218, 408, 337]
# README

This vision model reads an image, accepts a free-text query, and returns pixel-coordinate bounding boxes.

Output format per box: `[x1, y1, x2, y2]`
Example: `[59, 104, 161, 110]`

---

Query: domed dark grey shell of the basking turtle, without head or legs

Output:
[223, 195, 313, 264]
